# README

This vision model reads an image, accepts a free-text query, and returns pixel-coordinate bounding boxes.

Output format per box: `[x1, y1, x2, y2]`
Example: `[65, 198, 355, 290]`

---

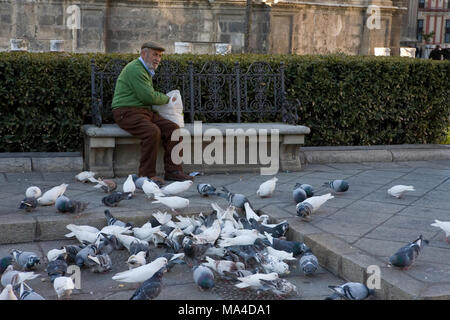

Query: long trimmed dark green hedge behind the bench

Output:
[0, 52, 450, 152]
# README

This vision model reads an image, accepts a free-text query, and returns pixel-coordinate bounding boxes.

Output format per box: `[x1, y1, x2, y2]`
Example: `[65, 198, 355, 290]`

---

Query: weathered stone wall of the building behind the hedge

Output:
[0, 0, 407, 54]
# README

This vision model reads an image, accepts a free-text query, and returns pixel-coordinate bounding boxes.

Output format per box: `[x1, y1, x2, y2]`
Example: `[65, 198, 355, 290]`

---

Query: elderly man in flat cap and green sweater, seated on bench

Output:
[111, 42, 193, 184]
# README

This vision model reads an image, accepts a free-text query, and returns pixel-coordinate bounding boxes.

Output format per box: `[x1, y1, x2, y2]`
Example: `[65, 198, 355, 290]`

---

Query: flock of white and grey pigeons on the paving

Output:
[0, 171, 442, 300]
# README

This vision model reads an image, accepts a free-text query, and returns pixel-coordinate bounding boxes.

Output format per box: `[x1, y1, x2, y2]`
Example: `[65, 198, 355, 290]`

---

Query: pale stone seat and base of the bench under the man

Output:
[82, 122, 310, 177]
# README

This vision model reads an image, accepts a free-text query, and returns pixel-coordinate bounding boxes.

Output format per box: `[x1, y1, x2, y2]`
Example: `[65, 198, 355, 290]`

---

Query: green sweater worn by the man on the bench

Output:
[111, 59, 170, 109]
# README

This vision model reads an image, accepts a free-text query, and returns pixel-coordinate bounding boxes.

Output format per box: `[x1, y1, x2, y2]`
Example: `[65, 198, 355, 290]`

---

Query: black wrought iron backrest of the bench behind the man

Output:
[91, 59, 300, 127]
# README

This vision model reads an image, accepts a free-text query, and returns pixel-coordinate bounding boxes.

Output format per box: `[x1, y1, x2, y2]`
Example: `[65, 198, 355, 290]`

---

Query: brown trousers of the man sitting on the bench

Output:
[113, 107, 183, 178]
